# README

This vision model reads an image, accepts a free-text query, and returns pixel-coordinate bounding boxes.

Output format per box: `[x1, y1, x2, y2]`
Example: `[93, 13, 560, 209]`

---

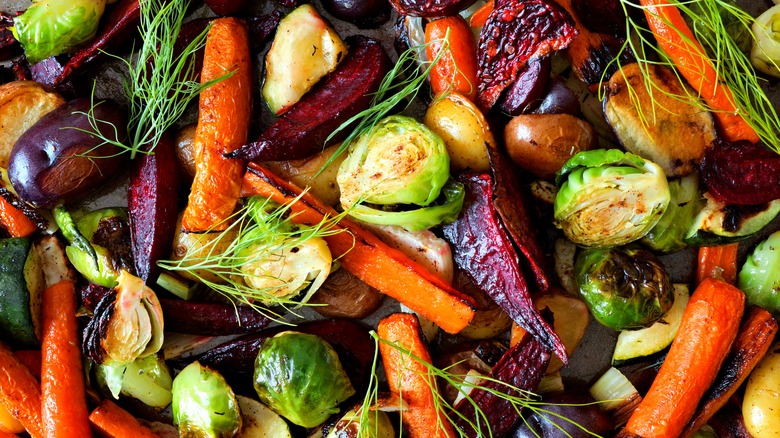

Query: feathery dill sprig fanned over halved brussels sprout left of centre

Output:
[157, 192, 346, 322]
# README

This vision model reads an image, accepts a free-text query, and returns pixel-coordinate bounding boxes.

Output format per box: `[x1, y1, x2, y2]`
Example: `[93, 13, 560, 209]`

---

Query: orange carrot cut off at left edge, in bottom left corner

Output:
[0, 343, 43, 438]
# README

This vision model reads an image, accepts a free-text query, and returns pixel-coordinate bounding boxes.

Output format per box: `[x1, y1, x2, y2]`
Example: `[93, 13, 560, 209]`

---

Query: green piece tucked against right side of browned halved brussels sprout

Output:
[642, 175, 704, 253]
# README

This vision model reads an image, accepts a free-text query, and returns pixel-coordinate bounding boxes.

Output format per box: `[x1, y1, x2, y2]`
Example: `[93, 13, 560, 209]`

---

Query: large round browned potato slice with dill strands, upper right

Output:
[604, 64, 715, 177]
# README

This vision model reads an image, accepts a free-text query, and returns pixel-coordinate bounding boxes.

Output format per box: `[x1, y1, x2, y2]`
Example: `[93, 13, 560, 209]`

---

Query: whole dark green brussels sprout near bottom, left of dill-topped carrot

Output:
[254, 331, 355, 427]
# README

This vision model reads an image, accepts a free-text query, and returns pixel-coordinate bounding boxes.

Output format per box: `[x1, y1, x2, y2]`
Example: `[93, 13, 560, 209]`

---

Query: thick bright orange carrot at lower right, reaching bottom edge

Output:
[618, 278, 745, 438]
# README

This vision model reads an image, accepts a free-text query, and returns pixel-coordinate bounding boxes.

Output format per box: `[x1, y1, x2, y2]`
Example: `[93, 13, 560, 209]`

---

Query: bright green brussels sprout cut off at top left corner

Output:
[11, 0, 106, 64]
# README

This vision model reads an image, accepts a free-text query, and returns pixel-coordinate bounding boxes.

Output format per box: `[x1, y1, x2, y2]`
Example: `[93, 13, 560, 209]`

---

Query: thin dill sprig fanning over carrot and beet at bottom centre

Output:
[357, 331, 600, 438]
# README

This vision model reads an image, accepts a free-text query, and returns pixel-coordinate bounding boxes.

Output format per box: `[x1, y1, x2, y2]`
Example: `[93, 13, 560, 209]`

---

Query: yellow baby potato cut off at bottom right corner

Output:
[742, 342, 780, 438]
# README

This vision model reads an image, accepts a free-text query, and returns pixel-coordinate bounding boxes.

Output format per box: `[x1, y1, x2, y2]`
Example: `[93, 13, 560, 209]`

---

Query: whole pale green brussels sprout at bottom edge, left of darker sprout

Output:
[171, 361, 241, 438]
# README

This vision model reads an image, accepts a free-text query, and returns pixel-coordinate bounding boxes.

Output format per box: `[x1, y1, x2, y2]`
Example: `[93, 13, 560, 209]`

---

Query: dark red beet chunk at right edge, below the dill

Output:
[701, 139, 780, 205]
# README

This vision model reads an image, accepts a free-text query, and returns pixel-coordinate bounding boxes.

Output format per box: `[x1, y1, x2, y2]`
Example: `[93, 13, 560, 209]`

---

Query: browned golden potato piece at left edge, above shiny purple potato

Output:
[0, 81, 65, 168]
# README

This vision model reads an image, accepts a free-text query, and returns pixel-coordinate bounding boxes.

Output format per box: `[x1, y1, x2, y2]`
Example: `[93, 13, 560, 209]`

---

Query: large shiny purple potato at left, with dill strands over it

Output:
[8, 99, 128, 208]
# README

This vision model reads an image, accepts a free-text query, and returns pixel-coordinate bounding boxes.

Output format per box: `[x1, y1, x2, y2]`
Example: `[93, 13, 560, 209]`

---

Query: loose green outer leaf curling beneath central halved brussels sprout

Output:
[350, 179, 466, 233]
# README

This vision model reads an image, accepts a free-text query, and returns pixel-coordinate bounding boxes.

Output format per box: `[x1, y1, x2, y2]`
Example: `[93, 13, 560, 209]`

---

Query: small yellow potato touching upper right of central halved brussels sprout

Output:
[423, 92, 496, 172]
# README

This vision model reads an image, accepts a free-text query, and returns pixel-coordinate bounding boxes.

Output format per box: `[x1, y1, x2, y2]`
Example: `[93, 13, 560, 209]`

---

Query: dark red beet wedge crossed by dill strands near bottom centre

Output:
[455, 336, 550, 437]
